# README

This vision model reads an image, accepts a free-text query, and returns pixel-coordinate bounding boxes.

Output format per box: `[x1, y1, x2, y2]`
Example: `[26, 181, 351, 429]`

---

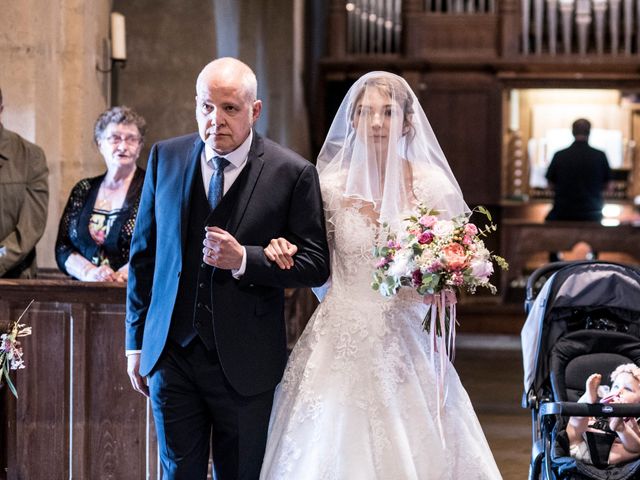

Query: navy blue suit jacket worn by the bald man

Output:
[126, 132, 329, 395]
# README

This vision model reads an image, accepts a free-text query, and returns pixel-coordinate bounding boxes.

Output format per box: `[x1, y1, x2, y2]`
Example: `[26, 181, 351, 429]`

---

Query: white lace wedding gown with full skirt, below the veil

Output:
[260, 175, 501, 480]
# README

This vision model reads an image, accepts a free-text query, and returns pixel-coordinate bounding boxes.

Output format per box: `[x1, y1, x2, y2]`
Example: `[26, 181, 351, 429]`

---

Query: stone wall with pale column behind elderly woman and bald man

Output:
[0, 0, 309, 268]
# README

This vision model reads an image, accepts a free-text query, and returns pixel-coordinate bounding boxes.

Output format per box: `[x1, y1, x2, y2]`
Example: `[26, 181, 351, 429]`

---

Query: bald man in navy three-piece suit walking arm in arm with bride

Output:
[126, 58, 329, 480]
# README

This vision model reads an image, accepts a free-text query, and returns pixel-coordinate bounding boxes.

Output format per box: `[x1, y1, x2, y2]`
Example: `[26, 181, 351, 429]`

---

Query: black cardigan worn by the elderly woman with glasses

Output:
[56, 168, 144, 274]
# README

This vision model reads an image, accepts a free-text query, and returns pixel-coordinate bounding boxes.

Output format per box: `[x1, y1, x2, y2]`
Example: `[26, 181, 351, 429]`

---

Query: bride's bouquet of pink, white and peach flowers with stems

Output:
[372, 204, 509, 336]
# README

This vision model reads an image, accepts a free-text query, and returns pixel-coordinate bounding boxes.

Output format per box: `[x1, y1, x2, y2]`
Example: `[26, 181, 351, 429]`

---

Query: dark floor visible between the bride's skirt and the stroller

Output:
[455, 337, 531, 480]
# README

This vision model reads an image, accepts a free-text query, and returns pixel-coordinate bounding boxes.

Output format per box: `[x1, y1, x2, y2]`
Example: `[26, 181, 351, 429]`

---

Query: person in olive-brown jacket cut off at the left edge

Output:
[0, 90, 49, 278]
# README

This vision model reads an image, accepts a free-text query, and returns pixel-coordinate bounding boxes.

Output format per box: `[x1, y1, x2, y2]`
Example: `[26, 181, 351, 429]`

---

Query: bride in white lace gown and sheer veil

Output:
[260, 72, 501, 480]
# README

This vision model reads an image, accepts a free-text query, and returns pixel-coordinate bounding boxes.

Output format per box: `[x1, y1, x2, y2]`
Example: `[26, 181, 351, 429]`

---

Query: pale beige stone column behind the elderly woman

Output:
[0, 0, 111, 268]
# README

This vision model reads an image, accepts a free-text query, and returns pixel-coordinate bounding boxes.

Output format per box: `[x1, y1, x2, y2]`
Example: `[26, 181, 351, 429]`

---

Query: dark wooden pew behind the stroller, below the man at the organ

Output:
[500, 219, 640, 295]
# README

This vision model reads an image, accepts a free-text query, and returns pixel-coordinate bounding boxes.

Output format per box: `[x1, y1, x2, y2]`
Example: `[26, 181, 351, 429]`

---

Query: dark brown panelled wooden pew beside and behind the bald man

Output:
[0, 279, 315, 480]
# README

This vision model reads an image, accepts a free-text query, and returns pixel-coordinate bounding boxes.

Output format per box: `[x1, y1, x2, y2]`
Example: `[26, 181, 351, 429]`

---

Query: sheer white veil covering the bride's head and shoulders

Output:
[317, 72, 469, 230]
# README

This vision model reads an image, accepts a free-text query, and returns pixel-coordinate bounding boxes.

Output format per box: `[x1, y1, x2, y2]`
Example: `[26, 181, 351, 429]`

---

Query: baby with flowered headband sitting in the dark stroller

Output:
[566, 363, 640, 466]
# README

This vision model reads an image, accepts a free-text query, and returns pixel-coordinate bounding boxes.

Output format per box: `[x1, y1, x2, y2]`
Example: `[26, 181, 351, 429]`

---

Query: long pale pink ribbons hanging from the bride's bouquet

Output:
[424, 290, 457, 446]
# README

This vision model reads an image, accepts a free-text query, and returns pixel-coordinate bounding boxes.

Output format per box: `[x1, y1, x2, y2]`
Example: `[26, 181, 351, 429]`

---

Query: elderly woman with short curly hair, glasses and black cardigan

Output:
[56, 106, 146, 282]
